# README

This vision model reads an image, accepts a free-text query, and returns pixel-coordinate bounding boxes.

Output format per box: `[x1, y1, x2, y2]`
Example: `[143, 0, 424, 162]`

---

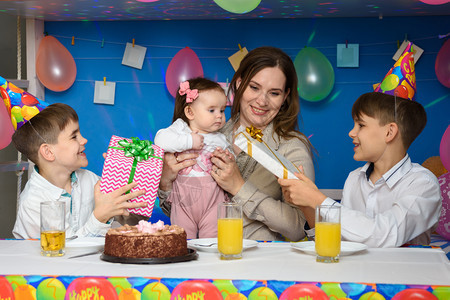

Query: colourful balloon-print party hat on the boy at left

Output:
[0, 76, 48, 130]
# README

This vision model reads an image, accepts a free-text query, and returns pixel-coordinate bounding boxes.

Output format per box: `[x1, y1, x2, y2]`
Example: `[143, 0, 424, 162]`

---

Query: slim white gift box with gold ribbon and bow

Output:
[234, 127, 300, 179]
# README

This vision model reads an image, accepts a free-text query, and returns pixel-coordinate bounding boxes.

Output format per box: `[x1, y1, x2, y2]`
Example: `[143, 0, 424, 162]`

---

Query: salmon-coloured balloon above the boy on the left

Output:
[36, 36, 77, 92]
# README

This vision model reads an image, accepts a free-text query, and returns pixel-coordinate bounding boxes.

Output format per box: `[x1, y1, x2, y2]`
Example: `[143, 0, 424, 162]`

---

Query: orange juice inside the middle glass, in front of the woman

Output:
[217, 218, 243, 255]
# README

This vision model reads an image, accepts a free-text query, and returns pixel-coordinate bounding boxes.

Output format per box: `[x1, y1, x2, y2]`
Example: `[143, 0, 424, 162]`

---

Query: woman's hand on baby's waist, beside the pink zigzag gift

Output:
[159, 152, 198, 191]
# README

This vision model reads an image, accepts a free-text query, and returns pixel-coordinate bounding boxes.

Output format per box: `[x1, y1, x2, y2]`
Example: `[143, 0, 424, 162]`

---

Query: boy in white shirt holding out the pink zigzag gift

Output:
[12, 103, 146, 239]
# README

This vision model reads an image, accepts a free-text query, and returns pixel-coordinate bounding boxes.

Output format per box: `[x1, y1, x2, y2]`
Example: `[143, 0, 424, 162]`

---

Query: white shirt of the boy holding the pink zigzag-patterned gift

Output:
[13, 168, 111, 239]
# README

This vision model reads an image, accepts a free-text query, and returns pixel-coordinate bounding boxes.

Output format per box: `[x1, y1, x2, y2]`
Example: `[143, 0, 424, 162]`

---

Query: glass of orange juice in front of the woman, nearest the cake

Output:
[217, 202, 243, 260]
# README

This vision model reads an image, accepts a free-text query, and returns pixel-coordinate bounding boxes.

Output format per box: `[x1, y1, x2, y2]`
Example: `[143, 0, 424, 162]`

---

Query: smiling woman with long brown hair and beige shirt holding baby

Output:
[159, 47, 314, 241]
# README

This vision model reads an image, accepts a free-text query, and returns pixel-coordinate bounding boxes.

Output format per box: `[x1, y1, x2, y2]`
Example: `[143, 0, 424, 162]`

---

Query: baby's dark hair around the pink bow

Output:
[172, 77, 225, 124]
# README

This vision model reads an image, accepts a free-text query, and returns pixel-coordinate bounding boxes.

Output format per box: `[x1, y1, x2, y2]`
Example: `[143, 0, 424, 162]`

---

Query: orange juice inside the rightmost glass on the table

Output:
[316, 222, 341, 257]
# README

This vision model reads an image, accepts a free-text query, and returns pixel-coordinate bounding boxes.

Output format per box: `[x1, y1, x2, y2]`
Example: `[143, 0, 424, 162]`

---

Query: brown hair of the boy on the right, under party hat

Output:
[352, 92, 427, 149]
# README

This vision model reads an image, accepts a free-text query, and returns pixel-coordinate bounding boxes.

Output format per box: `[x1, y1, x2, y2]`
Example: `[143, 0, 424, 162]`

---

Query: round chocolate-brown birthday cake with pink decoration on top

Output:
[104, 220, 188, 258]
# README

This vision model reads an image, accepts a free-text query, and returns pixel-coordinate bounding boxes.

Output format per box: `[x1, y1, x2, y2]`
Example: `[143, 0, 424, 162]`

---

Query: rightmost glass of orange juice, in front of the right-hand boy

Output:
[315, 205, 341, 263]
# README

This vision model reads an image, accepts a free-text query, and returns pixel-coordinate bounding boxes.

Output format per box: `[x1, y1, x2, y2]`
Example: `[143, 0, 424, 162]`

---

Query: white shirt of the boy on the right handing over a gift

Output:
[322, 154, 442, 247]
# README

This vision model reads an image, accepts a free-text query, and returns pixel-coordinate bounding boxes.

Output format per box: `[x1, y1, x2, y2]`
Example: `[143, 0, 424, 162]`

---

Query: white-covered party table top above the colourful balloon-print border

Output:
[0, 240, 450, 299]
